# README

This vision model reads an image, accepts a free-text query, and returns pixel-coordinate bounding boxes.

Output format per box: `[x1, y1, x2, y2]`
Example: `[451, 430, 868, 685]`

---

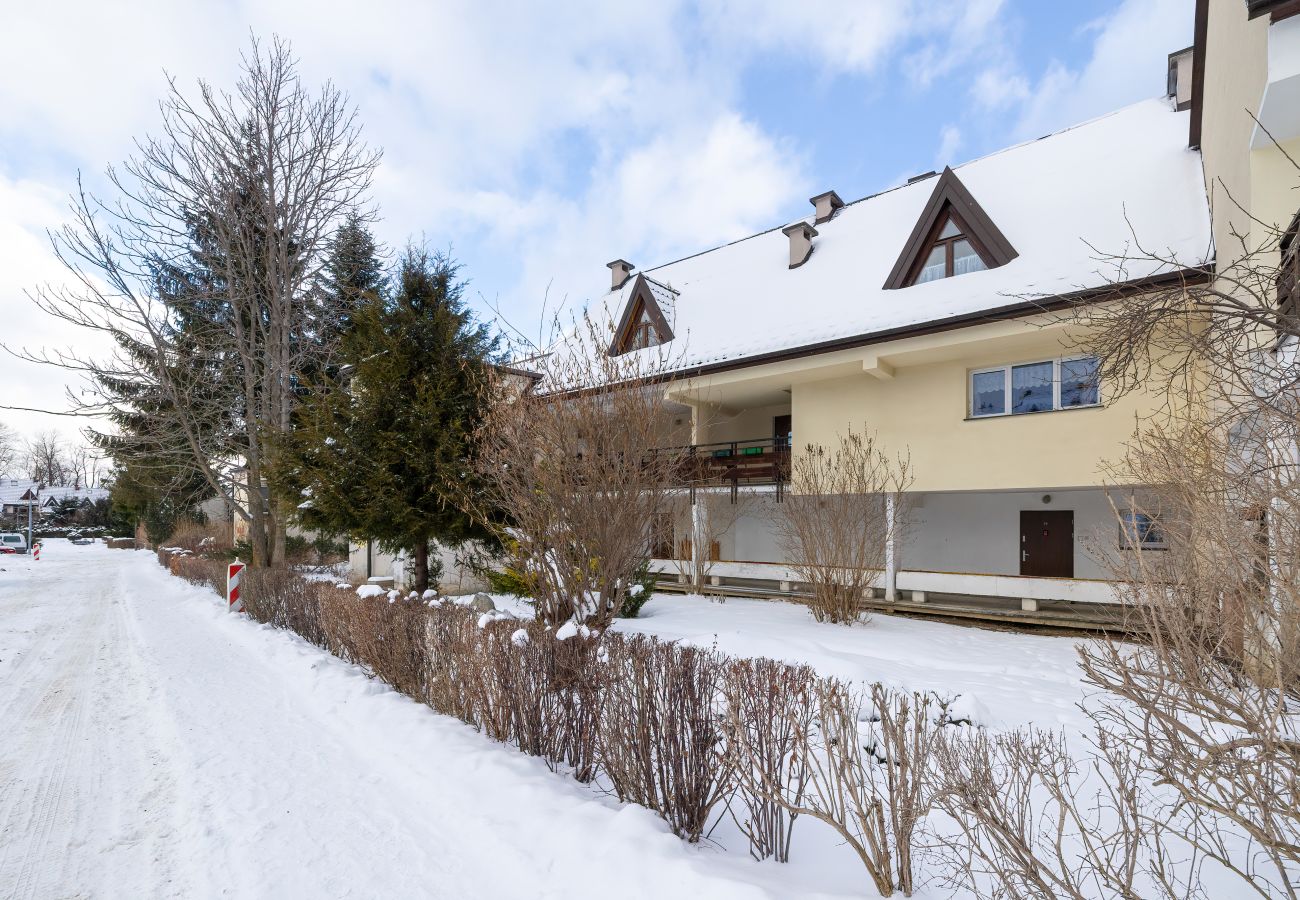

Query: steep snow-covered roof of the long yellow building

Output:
[593, 98, 1213, 377]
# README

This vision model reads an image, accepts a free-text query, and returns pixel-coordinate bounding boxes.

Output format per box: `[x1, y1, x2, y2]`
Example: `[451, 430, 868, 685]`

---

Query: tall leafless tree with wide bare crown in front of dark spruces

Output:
[22, 39, 378, 564]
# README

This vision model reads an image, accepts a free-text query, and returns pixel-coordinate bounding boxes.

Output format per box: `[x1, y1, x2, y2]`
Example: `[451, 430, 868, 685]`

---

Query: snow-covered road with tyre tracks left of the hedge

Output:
[0, 541, 852, 899]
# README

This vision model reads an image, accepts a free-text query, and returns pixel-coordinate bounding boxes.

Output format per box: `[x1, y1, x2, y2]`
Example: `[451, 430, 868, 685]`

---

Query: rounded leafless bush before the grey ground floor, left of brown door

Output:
[776, 428, 911, 624]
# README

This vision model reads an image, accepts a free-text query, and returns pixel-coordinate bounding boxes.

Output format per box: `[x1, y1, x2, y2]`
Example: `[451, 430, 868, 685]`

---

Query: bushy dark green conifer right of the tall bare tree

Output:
[277, 247, 497, 590]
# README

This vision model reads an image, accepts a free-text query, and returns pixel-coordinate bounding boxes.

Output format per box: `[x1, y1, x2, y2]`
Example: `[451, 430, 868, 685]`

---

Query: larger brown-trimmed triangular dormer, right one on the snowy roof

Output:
[885, 169, 1017, 290]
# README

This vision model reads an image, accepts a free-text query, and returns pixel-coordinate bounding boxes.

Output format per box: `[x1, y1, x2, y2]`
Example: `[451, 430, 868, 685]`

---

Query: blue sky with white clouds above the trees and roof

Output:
[0, 0, 1192, 442]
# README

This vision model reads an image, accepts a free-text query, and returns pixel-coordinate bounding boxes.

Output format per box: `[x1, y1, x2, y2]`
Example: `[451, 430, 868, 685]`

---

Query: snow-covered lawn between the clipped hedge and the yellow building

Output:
[494, 593, 1088, 730]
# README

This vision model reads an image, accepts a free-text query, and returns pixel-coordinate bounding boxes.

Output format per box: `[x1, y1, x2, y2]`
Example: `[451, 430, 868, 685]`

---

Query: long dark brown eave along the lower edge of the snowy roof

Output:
[673, 267, 1210, 378]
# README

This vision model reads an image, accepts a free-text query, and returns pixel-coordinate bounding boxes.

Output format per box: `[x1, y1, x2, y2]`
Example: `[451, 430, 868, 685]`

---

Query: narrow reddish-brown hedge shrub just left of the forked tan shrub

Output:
[724, 659, 816, 862]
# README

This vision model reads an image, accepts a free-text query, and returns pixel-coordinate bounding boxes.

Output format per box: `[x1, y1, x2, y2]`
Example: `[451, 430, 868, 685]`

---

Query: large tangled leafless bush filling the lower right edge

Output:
[1080, 416, 1300, 896]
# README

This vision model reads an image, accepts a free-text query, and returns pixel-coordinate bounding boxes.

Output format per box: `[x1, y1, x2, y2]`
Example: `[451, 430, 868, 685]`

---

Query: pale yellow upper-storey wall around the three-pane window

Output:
[696, 321, 1185, 490]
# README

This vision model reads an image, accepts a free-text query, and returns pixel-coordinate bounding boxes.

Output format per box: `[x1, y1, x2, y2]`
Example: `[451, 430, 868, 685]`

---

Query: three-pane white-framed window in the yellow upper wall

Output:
[970, 356, 1101, 419]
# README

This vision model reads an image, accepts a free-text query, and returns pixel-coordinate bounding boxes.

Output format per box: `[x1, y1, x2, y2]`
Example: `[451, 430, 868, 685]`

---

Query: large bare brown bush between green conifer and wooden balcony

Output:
[477, 319, 683, 626]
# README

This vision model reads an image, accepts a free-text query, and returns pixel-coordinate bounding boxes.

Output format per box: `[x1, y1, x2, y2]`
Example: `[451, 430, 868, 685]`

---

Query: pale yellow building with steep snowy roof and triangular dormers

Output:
[585, 7, 1300, 610]
